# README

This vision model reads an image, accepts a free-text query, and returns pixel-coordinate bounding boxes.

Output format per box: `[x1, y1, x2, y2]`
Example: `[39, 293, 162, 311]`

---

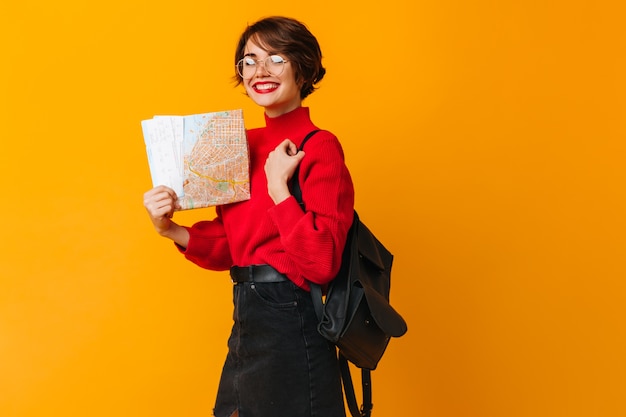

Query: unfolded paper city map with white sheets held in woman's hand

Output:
[141, 110, 250, 210]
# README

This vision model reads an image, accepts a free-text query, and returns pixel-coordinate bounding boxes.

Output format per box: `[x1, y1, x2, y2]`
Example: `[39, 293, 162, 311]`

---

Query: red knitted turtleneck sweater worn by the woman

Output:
[179, 107, 354, 289]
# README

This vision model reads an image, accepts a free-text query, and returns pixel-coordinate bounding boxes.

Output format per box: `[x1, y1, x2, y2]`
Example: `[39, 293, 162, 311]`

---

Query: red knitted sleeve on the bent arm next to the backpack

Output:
[269, 132, 354, 284]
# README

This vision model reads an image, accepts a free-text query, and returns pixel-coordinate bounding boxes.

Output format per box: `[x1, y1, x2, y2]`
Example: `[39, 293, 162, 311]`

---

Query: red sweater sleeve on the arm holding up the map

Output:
[177, 207, 232, 271]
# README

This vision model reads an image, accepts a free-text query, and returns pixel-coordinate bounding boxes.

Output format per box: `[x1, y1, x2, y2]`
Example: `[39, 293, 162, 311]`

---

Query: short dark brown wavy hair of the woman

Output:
[235, 16, 326, 99]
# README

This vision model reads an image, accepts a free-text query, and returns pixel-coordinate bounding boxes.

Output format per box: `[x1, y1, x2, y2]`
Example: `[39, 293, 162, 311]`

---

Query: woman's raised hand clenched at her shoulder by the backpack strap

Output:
[265, 139, 304, 204]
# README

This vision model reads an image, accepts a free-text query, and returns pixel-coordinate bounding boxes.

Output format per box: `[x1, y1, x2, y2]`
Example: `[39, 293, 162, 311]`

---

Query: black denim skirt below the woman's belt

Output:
[214, 281, 345, 417]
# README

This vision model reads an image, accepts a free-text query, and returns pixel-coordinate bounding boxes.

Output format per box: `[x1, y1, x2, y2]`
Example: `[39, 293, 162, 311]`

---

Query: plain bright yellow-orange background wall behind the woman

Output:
[0, 0, 626, 417]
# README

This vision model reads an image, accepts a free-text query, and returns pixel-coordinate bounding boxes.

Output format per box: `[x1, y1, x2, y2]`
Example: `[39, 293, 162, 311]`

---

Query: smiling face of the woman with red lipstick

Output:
[243, 40, 302, 117]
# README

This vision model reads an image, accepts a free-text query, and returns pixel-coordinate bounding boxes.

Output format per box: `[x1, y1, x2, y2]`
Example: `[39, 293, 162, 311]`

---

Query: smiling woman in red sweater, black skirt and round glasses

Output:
[144, 17, 354, 417]
